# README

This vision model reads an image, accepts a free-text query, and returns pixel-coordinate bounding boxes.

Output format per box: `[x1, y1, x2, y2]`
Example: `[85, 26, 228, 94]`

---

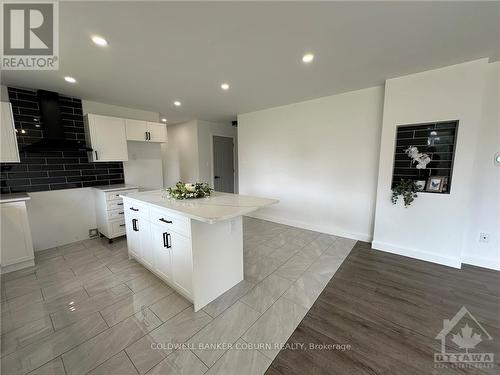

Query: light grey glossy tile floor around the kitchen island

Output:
[1, 218, 355, 375]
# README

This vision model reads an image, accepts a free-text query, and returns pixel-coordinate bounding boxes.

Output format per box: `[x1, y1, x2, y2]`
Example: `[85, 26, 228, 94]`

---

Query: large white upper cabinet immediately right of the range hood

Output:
[85, 113, 128, 162]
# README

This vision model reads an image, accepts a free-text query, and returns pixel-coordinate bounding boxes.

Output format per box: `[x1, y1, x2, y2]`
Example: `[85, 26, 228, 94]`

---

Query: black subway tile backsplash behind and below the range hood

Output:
[0, 87, 124, 194]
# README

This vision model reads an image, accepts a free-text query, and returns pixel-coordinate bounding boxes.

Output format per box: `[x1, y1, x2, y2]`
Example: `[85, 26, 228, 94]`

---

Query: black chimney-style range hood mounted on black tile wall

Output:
[23, 90, 92, 151]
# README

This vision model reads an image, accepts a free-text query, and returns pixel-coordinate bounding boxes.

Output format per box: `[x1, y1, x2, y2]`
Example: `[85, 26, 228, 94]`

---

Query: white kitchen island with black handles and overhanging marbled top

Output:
[122, 190, 278, 311]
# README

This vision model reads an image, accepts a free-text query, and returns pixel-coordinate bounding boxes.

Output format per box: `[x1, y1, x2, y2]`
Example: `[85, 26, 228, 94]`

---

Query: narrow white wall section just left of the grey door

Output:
[162, 120, 200, 186]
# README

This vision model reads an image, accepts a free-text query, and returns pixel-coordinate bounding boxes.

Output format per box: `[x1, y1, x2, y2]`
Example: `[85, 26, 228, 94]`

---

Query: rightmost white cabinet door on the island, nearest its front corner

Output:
[169, 232, 193, 295]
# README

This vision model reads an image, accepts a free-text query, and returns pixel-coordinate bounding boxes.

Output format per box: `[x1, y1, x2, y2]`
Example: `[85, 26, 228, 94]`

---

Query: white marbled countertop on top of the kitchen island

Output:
[123, 190, 279, 224]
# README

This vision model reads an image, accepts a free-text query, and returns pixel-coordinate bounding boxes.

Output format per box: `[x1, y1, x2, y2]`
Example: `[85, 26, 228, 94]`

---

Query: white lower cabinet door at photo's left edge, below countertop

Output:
[0, 202, 34, 267]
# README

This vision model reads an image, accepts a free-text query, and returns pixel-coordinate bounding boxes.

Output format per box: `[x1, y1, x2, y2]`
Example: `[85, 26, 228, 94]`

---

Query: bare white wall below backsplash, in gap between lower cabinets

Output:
[26, 188, 97, 251]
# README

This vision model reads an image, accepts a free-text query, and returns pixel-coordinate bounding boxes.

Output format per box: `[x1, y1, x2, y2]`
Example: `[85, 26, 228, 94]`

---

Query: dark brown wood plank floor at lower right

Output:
[266, 242, 500, 375]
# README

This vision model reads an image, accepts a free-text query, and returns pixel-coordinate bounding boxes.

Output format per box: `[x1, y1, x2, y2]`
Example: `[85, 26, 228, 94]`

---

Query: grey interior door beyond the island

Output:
[213, 135, 234, 193]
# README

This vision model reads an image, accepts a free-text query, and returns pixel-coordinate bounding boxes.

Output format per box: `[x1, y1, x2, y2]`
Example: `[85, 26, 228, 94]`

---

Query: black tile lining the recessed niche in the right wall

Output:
[392, 121, 458, 194]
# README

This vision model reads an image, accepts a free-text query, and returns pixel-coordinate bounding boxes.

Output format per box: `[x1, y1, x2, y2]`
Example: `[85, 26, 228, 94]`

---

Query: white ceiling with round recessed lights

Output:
[2, 1, 500, 123]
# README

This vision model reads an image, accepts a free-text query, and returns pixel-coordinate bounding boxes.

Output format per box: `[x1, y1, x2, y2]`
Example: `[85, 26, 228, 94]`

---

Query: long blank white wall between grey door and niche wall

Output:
[238, 87, 384, 240]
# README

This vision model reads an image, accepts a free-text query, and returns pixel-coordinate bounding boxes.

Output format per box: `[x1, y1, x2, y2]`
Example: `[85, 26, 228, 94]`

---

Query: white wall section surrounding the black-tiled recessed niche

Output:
[373, 59, 487, 267]
